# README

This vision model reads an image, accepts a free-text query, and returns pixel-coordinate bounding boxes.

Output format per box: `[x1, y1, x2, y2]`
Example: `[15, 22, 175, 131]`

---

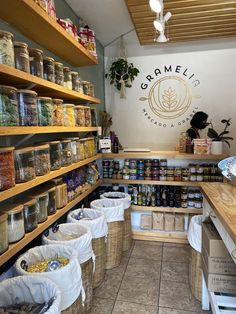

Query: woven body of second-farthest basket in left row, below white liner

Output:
[106, 221, 124, 269]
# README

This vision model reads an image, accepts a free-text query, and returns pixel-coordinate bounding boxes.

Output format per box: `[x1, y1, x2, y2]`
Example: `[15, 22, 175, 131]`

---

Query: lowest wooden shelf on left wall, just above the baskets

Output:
[0, 181, 100, 266]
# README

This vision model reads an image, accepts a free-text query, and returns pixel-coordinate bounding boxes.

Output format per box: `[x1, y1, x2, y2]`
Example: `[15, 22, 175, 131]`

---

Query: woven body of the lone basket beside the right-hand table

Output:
[189, 248, 202, 301]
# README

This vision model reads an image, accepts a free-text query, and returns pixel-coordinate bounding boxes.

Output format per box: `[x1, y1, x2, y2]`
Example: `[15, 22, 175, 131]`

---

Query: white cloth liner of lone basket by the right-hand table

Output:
[188, 215, 205, 253]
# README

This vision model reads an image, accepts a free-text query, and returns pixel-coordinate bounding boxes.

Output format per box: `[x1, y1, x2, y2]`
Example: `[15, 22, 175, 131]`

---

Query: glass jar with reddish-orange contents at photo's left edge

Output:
[0, 147, 15, 191]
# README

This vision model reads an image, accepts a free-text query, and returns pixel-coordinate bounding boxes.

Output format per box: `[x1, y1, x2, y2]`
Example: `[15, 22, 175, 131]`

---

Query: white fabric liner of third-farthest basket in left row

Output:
[67, 208, 108, 239]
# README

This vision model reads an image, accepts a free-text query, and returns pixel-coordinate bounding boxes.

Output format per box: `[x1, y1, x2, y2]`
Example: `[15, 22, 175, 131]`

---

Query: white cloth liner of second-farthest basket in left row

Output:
[90, 198, 124, 222]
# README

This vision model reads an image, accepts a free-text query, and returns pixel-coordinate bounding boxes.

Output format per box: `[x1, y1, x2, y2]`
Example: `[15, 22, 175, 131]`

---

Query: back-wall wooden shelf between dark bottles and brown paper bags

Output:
[131, 205, 202, 215]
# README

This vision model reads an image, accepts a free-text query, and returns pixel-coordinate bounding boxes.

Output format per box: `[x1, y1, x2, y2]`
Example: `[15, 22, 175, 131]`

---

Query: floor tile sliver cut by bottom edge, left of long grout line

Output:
[112, 301, 157, 314]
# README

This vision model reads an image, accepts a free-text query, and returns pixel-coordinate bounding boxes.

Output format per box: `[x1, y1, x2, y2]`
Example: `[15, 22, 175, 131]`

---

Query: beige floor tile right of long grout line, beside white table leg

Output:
[159, 281, 204, 313]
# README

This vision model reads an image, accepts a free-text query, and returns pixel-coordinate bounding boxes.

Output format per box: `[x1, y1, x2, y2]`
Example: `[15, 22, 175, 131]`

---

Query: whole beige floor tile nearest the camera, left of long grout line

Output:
[117, 275, 159, 306]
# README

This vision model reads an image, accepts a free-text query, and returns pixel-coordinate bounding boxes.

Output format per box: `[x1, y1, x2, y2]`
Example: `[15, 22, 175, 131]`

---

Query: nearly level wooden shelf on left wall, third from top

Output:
[0, 126, 98, 136]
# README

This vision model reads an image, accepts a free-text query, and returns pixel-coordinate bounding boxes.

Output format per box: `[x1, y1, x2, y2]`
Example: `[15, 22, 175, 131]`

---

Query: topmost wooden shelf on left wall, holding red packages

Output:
[0, 0, 97, 66]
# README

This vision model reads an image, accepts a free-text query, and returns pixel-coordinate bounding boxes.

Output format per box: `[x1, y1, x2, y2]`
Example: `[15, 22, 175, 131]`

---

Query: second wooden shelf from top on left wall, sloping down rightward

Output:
[0, 64, 100, 104]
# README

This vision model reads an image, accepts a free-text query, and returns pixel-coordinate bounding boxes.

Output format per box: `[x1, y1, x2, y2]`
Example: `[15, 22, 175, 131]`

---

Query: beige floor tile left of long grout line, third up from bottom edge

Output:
[125, 257, 161, 279]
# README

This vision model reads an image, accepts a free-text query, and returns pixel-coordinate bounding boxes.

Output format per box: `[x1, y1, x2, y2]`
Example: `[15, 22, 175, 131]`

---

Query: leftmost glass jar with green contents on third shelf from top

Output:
[0, 85, 19, 126]
